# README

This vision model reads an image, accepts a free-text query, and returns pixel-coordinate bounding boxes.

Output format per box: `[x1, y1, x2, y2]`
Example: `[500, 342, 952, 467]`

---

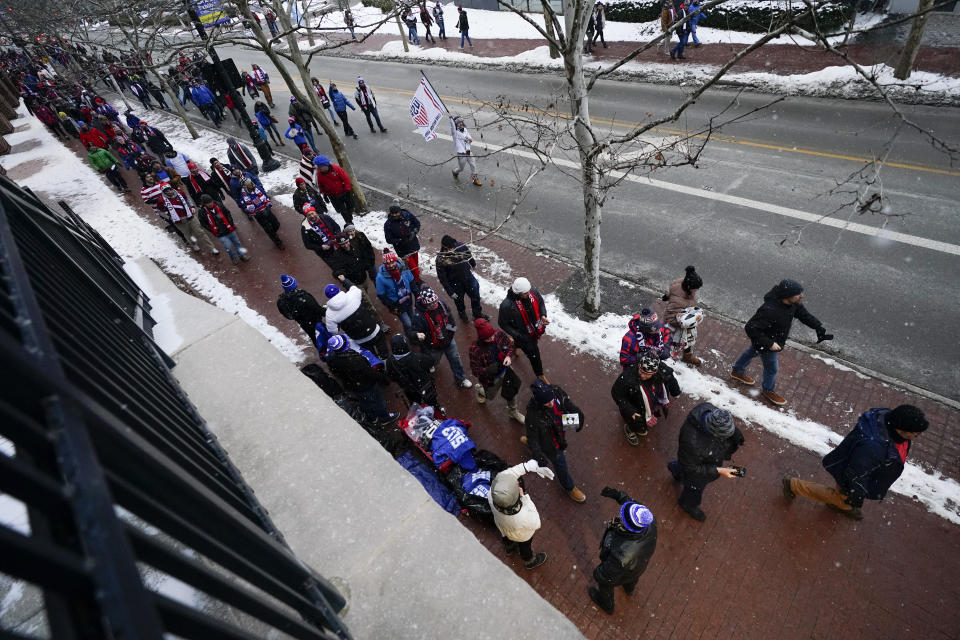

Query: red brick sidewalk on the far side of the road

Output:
[330, 33, 960, 77]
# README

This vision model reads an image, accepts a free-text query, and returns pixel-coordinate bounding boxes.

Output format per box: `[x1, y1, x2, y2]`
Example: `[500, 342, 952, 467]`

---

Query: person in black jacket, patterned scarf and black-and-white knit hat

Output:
[610, 349, 680, 447]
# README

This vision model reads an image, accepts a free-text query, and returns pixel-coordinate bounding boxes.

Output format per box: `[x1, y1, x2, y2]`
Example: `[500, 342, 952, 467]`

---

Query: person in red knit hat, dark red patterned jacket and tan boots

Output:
[470, 318, 526, 424]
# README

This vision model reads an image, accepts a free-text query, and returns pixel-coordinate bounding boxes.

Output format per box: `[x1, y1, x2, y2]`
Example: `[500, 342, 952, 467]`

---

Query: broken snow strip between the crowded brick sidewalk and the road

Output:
[344, 211, 960, 524]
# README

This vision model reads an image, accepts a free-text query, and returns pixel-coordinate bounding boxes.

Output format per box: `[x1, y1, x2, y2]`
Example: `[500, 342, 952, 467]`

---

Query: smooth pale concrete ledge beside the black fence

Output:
[132, 261, 583, 640]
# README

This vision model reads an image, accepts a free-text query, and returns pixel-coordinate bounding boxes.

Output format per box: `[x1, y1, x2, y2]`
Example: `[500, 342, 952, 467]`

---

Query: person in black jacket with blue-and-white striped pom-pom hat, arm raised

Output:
[587, 487, 657, 613]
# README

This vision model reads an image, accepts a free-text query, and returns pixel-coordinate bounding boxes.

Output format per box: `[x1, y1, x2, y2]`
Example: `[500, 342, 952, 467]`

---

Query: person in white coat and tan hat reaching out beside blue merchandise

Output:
[487, 460, 553, 569]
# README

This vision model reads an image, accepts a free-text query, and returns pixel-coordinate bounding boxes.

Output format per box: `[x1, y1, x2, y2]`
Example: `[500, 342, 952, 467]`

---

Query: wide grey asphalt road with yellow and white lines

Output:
[212, 49, 960, 399]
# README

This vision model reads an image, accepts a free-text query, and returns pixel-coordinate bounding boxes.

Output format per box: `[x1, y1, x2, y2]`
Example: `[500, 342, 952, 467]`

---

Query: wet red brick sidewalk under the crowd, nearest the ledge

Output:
[56, 132, 960, 640]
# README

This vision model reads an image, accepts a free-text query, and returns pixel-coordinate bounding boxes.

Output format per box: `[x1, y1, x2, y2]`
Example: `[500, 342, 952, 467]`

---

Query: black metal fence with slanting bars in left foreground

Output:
[0, 171, 350, 640]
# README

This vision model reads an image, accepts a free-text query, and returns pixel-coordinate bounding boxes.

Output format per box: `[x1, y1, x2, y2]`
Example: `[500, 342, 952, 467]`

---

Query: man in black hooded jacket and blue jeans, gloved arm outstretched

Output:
[730, 279, 833, 406]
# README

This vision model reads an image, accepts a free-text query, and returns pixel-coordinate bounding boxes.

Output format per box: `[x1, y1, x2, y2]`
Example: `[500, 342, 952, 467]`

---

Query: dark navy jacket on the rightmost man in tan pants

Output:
[823, 408, 910, 506]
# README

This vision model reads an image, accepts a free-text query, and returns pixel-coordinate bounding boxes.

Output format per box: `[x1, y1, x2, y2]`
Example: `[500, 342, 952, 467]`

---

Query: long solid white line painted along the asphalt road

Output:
[437, 133, 960, 256]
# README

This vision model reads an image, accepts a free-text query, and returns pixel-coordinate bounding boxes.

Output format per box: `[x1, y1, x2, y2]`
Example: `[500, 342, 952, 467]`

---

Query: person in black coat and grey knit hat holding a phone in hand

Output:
[667, 402, 746, 522]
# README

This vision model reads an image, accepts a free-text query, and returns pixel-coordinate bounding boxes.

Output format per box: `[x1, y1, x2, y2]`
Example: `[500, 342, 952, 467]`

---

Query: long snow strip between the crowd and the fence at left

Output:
[4, 106, 303, 362]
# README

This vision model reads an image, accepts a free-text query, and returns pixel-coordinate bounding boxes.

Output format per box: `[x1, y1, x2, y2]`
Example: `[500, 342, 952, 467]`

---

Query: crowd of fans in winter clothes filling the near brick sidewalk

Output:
[9, 36, 927, 613]
